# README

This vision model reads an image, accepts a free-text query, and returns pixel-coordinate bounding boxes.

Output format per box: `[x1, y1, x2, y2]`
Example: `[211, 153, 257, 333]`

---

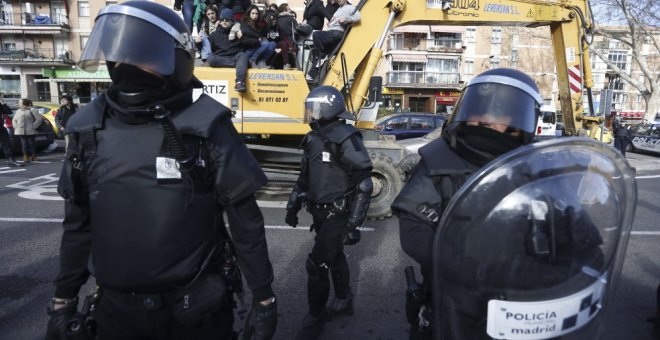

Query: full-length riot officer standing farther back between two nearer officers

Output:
[286, 86, 372, 339]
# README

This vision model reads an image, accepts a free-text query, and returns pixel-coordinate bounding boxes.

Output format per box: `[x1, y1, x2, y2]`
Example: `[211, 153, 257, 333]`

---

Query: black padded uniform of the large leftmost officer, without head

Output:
[55, 89, 273, 339]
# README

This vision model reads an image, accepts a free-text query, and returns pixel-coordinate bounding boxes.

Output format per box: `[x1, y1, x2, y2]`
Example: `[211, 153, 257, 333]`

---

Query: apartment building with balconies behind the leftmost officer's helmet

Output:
[0, 0, 172, 103]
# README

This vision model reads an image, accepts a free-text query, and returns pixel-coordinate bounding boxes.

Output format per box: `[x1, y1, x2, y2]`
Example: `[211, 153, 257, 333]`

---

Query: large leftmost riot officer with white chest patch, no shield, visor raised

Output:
[47, 1, 277, 339]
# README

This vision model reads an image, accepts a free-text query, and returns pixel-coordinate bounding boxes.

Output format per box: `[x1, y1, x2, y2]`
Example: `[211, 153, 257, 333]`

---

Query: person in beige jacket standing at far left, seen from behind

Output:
[11, 98, 44, 163]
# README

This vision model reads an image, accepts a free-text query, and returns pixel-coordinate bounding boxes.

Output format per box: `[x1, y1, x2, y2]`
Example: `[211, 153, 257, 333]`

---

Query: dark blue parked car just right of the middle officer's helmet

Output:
[375, 112, 447, 140]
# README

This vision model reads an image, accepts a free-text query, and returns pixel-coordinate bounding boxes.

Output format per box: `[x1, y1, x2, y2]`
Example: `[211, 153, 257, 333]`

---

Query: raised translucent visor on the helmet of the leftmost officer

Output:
[78, 13, 182, 76]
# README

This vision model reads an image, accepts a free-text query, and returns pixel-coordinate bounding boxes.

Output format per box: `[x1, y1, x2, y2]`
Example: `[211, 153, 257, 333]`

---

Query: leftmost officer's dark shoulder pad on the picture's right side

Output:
[171, 94, 231, 138]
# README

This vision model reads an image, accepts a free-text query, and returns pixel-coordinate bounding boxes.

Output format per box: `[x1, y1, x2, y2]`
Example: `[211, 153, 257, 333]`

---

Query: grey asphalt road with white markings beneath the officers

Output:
[0, 141, 660, 340]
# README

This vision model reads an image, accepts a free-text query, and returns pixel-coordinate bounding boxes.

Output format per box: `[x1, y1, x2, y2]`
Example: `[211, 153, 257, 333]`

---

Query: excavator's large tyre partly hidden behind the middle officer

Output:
[367, 151, 404, 220]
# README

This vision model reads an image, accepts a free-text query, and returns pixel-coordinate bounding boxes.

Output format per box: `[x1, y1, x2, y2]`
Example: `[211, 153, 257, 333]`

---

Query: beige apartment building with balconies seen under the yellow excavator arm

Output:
[377, 25, 557, 113]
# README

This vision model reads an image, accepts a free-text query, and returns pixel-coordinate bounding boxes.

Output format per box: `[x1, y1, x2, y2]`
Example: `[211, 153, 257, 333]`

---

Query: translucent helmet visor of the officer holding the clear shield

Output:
[451, 83, 539, 133]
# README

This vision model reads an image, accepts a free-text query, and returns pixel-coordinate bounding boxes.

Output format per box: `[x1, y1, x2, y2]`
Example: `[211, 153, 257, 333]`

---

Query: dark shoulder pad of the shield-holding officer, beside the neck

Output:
[419, 137, 475, 176]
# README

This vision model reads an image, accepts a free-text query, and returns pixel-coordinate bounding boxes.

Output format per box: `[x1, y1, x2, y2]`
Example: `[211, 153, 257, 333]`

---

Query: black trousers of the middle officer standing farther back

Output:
[307, 210, 351, 316]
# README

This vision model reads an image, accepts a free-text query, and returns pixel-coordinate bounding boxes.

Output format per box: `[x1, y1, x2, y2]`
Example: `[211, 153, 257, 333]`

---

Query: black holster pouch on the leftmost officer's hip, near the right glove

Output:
[172, 273, 229, 326]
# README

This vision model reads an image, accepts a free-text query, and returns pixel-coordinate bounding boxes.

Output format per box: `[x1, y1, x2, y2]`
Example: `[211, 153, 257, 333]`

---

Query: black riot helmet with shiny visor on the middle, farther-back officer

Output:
[305, 86, 355, 122]
